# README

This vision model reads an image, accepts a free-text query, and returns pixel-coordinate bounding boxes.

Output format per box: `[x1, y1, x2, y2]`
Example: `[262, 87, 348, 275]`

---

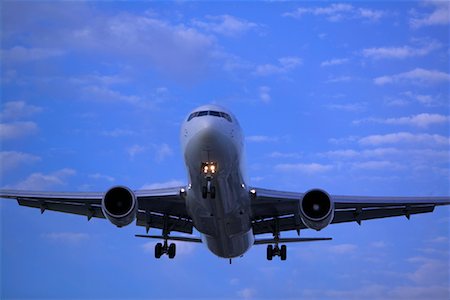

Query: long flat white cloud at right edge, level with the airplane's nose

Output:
[359, 132, 450, 146]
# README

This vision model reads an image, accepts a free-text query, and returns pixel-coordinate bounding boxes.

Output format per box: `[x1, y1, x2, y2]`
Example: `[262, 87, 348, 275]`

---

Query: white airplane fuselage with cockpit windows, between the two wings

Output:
[181, 105, 254, 258]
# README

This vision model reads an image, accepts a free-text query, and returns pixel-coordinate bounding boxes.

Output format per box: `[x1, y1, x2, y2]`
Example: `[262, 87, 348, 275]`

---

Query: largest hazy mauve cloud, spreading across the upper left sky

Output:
[2, 3, 221, 81]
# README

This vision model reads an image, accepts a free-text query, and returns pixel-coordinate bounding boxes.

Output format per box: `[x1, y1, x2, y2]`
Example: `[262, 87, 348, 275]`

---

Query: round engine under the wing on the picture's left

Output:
[102, 186, 138, 227]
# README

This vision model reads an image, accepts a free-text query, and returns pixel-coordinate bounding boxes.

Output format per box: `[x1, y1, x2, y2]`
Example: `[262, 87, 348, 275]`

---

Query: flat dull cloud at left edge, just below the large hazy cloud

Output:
[1, 46, 65, 63]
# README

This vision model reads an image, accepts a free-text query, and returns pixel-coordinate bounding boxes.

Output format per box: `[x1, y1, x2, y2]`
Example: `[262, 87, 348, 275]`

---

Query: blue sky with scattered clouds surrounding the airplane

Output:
[0, 1, 450, 299]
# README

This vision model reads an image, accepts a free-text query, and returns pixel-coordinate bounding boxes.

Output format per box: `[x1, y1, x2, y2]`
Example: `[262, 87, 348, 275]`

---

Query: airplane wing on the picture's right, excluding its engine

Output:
[252, 188, 450, 234]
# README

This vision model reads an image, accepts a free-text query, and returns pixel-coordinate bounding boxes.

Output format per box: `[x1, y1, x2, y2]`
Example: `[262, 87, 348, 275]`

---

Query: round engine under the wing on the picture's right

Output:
[300, 189, 334, 231]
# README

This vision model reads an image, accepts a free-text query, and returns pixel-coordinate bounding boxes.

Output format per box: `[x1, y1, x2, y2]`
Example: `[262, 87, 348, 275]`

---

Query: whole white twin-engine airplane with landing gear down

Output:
[0, 105, 450, 263]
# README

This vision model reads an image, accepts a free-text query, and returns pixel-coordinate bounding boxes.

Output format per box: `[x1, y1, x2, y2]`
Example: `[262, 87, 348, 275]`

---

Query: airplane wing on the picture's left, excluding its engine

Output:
[0, 187, 193, 233]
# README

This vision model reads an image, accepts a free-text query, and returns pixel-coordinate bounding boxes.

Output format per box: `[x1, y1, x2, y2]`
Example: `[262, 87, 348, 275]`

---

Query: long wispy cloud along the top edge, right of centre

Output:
[283, 3, 386, 22]
